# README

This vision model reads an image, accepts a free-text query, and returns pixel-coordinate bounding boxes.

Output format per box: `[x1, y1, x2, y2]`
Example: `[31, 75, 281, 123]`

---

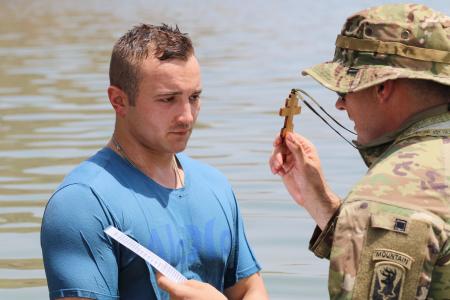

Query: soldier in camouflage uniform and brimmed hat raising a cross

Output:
[270, 4, 450, 299]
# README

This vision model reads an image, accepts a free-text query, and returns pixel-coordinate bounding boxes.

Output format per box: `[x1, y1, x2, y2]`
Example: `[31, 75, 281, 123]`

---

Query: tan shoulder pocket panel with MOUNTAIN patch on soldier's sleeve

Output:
[353, 213, 432, 300]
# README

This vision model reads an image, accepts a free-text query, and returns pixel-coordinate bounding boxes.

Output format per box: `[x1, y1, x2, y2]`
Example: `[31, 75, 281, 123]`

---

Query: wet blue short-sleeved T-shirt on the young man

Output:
[41, 148, 260, 300]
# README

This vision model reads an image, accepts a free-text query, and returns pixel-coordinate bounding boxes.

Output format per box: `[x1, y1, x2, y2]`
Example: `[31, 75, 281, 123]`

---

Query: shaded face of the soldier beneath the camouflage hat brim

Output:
[335, 87, 386, 145]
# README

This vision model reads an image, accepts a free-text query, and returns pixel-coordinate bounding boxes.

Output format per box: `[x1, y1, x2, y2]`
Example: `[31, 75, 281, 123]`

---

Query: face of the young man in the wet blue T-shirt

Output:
[126, 55, 202, 154]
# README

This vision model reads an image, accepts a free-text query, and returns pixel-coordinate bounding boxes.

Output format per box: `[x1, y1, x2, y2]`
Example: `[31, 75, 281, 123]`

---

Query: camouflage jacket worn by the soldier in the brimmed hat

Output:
[310, 106, 450, 299]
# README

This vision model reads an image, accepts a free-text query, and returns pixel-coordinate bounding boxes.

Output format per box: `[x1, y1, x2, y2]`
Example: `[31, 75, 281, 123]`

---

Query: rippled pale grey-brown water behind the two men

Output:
[0, 0, 449, 299]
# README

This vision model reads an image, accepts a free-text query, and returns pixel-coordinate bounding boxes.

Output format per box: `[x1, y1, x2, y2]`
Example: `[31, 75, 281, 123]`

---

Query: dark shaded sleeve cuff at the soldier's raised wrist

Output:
[309, 208, 340, 259]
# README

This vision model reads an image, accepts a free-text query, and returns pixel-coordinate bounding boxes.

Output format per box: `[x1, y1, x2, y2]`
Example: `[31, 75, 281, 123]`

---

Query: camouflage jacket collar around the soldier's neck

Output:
[354, 104, 450, 167]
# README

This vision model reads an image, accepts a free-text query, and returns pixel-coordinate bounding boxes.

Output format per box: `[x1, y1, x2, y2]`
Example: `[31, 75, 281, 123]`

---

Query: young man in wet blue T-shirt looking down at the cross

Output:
[41, 24, 267, 300]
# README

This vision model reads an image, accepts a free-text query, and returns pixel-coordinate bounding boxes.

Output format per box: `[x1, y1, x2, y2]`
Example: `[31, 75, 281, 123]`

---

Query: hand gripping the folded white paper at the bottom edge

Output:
[156, 273, 227, 300]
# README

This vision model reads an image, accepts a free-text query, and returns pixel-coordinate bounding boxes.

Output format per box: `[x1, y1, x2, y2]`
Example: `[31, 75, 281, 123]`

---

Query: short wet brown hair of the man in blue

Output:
[109, 24, 194, 105]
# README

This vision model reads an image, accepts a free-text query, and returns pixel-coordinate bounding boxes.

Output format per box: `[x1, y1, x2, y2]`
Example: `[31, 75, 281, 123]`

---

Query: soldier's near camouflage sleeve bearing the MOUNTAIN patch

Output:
[329, 199, 450, 299]
